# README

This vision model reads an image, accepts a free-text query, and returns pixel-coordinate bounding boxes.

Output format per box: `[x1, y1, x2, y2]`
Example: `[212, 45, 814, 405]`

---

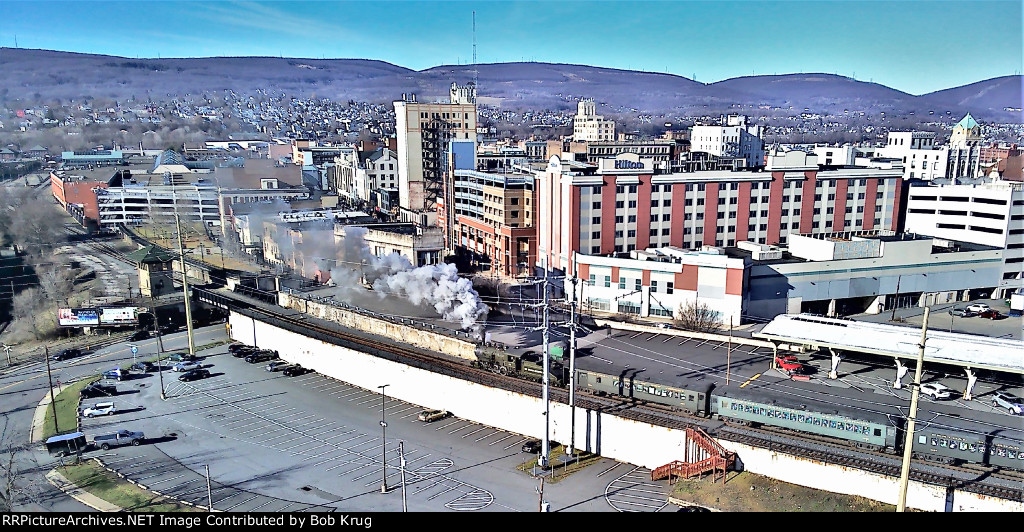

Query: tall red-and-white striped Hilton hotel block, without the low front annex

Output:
[536, 150, 904, 273]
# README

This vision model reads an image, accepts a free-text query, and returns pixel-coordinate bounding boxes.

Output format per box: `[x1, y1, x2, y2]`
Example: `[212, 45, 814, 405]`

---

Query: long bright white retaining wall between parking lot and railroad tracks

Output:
[228, 312, 1024, 512]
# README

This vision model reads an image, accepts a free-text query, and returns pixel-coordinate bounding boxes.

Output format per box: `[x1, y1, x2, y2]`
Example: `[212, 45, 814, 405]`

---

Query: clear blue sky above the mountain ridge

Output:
[0, 0, 1024, 94]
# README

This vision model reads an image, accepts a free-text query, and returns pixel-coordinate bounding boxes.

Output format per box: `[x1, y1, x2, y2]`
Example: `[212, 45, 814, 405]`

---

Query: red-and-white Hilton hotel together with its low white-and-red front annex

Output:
[535, 150, 904, 323]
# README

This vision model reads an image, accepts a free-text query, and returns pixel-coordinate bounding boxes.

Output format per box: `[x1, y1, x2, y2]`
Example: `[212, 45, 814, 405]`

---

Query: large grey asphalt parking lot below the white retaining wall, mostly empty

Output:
[77, 348, 669, 512]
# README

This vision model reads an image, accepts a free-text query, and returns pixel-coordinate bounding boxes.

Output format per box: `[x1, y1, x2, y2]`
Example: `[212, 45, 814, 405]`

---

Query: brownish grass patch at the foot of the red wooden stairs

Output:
[672, 472, 896, 513]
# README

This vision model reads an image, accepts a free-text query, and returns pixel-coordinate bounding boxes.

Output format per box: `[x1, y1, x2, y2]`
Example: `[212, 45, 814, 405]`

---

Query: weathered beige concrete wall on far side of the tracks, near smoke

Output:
[276, 292, 476, 361]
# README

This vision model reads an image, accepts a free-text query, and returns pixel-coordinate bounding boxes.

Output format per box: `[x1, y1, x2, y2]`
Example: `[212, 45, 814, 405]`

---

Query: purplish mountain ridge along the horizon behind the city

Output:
[0, 47, 1024, 122]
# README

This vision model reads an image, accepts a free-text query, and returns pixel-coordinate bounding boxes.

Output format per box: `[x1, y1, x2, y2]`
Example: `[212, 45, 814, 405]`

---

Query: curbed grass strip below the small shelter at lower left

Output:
[58, 460, 204, 512]
